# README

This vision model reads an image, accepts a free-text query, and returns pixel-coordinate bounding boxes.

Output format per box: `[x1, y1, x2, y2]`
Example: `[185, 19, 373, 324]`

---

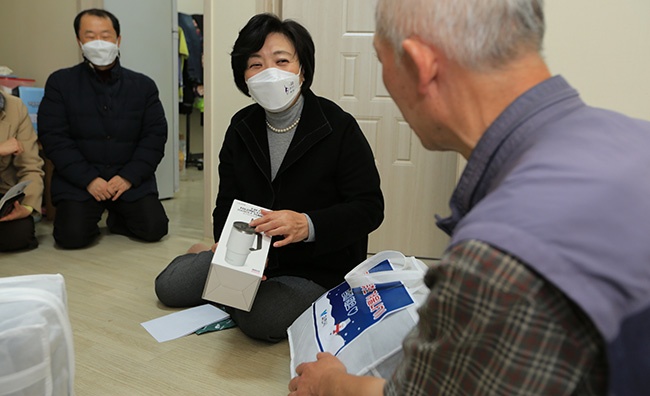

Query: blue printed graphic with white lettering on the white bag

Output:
[314, 260, 414, 355]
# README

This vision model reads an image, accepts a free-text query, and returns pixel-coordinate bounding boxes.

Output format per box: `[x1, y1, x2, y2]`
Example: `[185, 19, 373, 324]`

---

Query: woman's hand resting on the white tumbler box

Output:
[250, 210, 309, 247]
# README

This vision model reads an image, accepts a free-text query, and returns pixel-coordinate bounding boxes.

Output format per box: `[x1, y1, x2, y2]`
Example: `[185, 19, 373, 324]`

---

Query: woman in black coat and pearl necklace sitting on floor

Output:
[155, 14, 384, 342]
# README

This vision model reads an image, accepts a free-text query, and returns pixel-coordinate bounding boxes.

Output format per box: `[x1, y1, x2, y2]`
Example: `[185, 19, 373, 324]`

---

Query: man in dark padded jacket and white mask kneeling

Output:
[38, 9, 168, 249]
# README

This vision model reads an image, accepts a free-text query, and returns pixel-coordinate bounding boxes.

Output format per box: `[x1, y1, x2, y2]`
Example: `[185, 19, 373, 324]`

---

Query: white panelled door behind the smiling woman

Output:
[282, 0, 459, 258]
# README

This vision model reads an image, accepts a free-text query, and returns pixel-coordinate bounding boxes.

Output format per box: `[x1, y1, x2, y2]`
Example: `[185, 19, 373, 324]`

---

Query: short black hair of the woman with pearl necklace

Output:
[230, 14, 315, 96]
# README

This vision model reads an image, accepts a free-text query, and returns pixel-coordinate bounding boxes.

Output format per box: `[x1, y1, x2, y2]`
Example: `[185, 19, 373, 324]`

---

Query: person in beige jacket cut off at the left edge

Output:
[0, 92, 43, 252]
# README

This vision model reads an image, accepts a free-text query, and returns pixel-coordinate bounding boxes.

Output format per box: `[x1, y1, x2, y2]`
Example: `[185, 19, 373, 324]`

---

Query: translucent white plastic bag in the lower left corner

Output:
[0, 274, 74, 396]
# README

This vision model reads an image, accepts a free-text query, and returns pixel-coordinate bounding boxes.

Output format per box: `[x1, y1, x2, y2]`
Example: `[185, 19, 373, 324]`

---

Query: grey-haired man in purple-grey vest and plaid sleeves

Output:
[289, 0, 650, 396]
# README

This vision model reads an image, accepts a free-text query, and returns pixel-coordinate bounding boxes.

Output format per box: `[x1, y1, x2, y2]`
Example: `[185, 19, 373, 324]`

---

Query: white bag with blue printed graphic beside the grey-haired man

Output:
[287, 251, 428, 378]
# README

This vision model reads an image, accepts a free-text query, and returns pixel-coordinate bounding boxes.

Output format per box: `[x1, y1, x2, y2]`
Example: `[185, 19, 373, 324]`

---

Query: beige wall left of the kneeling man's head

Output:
[0, 0, 81, 87]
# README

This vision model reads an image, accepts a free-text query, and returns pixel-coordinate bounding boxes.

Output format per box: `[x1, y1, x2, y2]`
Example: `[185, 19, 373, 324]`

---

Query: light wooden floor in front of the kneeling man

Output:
[0, 168, 289, 396]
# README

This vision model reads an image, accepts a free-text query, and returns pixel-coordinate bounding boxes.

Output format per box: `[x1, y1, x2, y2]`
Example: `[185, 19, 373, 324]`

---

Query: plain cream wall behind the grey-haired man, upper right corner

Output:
[544, 0, 650, 120]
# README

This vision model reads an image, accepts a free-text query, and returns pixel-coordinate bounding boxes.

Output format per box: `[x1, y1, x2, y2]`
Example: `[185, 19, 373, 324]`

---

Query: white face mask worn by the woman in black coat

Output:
[246, 67, 300, 113]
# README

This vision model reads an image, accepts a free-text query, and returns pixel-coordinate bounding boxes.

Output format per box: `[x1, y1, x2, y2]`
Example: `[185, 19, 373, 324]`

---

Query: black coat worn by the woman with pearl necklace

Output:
[213, 91, 384, 288]
